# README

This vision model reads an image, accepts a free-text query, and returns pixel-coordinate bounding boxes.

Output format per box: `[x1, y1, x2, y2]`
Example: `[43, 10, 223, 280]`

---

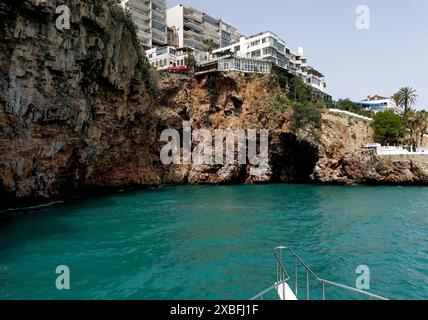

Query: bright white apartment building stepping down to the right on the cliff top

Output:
[213, 31, 326, 92]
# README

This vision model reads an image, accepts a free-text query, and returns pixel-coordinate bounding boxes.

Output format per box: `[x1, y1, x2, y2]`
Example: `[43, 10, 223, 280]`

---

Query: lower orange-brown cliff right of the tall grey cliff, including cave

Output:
[156, 73, 428, 184]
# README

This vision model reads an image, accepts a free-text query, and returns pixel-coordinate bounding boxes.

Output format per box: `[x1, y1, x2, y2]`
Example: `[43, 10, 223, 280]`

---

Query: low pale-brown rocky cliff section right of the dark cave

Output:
[311, 114, 428, 185]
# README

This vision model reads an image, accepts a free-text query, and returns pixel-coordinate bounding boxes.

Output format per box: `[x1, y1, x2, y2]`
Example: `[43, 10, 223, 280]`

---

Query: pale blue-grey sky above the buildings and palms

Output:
[167, 0, 428, 109]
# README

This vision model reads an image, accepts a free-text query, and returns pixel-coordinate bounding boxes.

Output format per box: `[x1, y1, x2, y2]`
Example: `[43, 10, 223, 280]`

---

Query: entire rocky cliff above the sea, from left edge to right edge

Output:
[0, 0, 428, 210]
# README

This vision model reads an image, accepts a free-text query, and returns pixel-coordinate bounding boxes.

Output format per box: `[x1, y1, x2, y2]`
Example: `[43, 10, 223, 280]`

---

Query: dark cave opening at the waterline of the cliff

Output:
[271, 133, 319, 183]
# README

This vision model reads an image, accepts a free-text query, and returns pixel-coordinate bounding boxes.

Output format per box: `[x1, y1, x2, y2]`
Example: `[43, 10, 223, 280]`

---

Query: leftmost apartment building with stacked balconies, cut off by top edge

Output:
[122, 0, 168, 49]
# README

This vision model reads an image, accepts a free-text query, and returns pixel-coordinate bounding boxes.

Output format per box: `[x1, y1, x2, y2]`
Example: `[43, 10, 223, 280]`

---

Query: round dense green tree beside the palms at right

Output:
[372, 110, 407, 145]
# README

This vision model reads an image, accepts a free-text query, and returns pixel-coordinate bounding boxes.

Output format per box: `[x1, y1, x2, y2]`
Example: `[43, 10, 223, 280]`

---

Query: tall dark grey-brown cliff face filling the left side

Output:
[0, 0, 160, 208]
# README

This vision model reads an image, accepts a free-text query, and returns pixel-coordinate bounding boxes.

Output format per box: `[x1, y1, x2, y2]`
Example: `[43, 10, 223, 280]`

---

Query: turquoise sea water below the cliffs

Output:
[0, 185, 428, 299]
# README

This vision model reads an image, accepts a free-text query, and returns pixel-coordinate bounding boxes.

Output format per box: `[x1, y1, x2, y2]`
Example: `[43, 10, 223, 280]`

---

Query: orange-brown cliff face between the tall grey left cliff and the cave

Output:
[156, 73, 287, 184]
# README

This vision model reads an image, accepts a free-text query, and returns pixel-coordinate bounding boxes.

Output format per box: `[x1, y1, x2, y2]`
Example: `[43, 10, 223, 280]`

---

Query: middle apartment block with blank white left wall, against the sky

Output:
[167, 4, 240, 51]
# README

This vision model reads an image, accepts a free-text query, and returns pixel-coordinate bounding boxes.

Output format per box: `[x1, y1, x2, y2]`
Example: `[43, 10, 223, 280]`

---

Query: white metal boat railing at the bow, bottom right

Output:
[251, 247, 388, 300]
